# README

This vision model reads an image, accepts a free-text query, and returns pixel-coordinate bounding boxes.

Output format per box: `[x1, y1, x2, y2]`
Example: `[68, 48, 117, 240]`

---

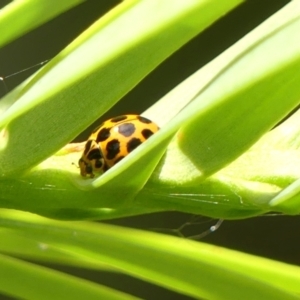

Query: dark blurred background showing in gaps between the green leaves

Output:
[0, 0, 300, 299]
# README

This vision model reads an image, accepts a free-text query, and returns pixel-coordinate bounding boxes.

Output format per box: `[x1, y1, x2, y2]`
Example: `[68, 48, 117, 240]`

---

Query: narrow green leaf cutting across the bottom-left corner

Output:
[0, 254, 137, 300]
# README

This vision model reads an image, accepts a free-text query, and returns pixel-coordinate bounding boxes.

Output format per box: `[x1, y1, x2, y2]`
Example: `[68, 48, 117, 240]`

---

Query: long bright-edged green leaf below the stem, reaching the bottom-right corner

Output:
[0, 211, 300, 299]
